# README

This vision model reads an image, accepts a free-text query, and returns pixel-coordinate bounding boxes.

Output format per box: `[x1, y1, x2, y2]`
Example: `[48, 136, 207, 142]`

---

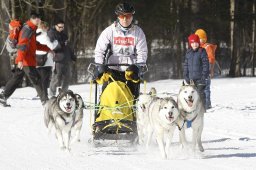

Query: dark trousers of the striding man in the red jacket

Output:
[4, 66, 48, 101]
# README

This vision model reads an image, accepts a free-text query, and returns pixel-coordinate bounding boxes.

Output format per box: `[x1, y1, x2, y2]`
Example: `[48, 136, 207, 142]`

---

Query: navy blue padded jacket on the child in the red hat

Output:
[183, 48, 209, 83]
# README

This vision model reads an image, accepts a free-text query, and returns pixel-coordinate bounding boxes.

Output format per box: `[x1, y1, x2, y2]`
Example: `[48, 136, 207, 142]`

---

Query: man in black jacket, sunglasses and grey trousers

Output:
[48, 20, 76, 96]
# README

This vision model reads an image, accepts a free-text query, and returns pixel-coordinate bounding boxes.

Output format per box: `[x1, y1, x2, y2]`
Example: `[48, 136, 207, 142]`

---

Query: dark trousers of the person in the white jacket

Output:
[37, 66, 52, 96]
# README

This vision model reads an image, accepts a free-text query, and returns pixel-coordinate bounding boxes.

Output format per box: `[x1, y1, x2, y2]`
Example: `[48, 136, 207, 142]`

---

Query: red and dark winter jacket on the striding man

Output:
[15, 21, 50, 66]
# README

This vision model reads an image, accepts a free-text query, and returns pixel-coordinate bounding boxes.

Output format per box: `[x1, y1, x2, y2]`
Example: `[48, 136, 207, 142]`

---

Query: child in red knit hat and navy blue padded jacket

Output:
[183, 34, 209, 108]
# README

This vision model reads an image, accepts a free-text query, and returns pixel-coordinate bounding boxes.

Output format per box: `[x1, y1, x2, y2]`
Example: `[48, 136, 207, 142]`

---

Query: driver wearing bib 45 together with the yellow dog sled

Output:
[90, 2, 148, 141]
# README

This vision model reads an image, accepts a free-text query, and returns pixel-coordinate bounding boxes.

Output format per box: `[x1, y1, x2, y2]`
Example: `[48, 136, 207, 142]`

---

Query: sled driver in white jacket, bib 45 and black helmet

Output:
[95, 2, 148, 98]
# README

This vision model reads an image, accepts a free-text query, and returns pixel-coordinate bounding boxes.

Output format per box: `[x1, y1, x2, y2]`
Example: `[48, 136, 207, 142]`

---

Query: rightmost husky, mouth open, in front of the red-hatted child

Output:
[178, 82, 205, 152]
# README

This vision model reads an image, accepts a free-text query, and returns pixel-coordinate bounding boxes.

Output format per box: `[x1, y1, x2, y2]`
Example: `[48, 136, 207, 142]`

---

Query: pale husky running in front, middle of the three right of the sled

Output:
[147, 97, 179, 159]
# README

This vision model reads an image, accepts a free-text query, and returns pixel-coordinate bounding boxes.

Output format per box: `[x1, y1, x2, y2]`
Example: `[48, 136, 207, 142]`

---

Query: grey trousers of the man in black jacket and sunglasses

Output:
[49, 63, 71, 96]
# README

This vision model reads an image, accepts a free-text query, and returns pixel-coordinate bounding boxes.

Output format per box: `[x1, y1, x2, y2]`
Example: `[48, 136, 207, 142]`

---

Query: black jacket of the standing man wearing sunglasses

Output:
[47, 27, 68, 63]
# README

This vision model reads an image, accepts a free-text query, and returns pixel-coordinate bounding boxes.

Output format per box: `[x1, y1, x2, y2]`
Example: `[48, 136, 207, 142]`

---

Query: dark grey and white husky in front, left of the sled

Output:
[44, 89, 77, 151]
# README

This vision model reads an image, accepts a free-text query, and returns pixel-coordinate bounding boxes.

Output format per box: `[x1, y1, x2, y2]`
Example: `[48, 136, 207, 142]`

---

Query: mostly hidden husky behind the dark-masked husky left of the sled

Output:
[71, 94, 85, 143]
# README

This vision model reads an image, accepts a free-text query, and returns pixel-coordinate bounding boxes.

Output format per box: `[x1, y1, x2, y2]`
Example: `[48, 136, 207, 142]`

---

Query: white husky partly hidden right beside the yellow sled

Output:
[137, 87, 156, 144]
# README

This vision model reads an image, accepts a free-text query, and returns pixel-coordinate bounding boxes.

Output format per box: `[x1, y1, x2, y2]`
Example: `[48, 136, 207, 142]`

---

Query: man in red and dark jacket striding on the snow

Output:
[0, 13, 50, 106]
